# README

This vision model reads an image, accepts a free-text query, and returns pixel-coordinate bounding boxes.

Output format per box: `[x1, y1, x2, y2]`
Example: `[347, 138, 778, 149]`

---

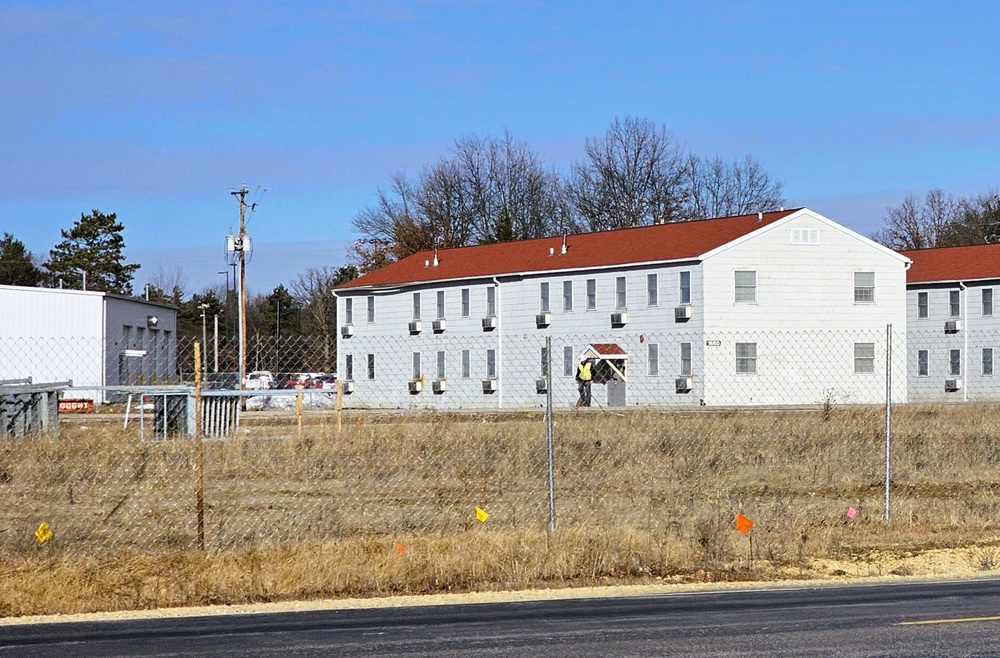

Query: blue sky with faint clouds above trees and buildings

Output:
[0, 0, 1000, 292]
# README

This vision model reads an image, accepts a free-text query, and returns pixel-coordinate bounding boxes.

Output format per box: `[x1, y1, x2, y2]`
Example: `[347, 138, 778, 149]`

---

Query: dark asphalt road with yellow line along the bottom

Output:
[0, 580, 1000, 658]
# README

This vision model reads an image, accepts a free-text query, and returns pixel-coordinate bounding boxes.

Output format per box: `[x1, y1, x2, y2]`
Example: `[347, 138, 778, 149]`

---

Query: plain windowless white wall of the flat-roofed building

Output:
[0, 286, 104, 386]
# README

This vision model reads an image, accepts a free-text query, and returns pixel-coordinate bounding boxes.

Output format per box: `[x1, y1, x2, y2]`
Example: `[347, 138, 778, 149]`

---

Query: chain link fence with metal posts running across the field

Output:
[0, 330, 1000, 560]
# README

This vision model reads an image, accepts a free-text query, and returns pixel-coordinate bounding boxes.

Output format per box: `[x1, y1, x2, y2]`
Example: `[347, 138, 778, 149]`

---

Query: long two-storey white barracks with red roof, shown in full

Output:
[336, 208, 909, 408]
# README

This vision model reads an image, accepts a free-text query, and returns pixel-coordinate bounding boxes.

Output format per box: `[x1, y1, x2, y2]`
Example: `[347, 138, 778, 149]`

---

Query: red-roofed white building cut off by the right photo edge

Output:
[902, 244, 1000, 401]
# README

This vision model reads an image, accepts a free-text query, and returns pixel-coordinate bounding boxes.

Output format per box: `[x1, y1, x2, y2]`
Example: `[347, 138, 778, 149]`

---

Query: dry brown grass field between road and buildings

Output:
[0, 404, 1000, 615]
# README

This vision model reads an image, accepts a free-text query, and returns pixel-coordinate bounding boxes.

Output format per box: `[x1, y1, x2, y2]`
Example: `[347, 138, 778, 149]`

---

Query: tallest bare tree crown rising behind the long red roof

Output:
[569, 116, 687, 231]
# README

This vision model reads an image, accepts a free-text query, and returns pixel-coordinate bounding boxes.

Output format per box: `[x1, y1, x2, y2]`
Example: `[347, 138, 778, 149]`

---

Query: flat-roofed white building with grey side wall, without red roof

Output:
[0, 286, 177, 402]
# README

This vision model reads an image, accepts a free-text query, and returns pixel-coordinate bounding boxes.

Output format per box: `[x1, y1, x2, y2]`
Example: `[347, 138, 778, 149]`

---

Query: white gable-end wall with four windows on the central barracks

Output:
[704, 211, 906, 406]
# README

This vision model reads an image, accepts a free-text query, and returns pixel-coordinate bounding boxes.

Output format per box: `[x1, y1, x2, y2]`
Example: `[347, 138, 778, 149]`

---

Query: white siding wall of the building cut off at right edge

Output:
[906, 281, 1000, 402]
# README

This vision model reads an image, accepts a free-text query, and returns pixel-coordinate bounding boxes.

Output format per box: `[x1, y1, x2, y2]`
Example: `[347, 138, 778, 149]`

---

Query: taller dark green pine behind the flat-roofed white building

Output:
[45, 209, 139, 295]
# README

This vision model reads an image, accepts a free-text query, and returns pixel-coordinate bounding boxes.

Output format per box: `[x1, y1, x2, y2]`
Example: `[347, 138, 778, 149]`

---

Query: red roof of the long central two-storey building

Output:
[339, 209, 798, 289]
